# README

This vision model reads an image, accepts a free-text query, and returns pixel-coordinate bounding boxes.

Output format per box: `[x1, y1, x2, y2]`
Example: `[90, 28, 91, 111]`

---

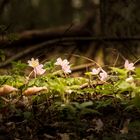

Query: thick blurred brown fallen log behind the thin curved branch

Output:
[0, 14, 94, 48]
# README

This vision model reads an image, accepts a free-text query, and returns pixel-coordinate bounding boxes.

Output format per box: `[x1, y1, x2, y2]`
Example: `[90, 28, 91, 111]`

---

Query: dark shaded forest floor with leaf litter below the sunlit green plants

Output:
[0, 87, 140, 140]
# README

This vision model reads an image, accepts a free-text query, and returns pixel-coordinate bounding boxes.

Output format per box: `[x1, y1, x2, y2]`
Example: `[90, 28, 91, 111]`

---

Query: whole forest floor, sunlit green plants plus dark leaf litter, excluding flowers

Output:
[0, 45, 140, 140]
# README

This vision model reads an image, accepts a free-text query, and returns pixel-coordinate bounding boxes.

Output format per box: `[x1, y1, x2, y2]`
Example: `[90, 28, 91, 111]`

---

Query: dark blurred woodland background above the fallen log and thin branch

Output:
[0, 0, 140, 36]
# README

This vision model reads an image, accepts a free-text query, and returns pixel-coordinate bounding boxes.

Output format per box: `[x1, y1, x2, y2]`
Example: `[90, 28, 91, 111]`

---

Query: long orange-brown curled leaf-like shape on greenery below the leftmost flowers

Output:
[23, 86, 48, 96]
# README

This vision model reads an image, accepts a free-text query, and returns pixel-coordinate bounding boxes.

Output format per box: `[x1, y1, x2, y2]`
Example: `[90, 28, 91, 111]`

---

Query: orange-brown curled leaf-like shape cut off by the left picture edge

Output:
[0, 85, 18, 96]
